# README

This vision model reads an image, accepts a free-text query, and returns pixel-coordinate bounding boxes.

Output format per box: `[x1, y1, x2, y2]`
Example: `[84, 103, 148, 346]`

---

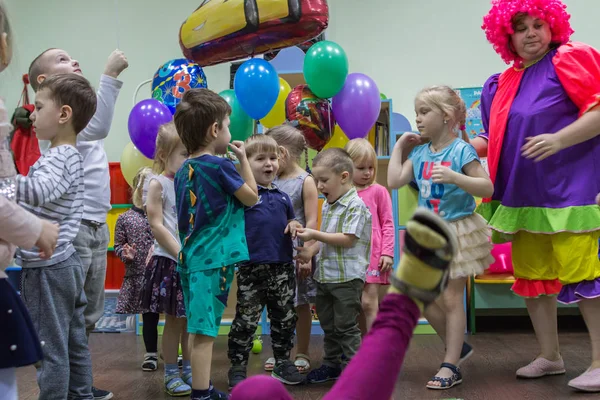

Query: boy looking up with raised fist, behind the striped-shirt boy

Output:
[29, 49, 128, 400]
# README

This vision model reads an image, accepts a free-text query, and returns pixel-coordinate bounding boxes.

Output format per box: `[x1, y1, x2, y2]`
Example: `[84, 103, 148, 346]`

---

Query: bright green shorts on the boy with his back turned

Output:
[180, 265, 235, 337]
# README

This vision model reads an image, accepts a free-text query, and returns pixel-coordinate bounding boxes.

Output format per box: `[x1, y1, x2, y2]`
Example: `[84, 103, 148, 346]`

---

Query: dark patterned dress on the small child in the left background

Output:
[115, 206, 154, 314]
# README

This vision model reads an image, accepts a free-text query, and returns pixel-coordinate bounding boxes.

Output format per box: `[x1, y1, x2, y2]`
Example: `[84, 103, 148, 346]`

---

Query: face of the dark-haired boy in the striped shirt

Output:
[29, 89, 64, 140]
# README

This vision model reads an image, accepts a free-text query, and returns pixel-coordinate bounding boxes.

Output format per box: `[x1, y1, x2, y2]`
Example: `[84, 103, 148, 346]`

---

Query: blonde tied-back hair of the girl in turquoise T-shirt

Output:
[416, 86, 469, 142]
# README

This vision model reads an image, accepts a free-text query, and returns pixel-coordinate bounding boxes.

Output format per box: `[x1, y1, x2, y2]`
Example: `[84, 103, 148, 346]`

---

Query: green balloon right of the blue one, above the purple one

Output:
[304, 40, 348, 99]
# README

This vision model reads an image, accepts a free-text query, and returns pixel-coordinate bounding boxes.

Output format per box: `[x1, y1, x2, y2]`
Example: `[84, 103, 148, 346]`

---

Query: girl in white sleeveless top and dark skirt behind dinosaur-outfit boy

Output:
[142, 122, 192, 396]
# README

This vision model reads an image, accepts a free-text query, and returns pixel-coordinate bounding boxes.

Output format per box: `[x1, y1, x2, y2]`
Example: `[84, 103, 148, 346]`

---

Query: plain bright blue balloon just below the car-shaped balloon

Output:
[233, 58, 279, 120]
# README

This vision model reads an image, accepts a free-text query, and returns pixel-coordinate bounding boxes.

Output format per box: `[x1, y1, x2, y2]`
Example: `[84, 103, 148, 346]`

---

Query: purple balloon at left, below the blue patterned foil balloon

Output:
[127, 99, 173, 159]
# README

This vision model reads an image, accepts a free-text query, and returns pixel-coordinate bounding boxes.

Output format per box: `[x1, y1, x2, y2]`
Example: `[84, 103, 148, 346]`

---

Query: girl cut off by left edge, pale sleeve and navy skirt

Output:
[0, 1, 58, 400]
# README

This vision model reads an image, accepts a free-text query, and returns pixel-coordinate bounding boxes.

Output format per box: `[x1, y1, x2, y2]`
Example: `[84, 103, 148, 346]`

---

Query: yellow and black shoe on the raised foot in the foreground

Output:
[391, 208, 458, 308]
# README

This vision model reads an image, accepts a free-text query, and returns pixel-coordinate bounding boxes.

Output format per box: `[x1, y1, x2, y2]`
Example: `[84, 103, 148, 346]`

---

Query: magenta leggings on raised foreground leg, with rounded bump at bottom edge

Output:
[230, 294, 420, 400]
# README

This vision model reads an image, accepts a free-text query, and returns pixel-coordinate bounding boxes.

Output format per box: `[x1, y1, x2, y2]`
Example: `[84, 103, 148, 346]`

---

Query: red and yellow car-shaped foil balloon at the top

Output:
[179, 0, 329, 67]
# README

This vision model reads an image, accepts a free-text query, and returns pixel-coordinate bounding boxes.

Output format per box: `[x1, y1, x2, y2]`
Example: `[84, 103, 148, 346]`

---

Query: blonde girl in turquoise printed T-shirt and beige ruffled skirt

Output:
[388, 86, 494, 389]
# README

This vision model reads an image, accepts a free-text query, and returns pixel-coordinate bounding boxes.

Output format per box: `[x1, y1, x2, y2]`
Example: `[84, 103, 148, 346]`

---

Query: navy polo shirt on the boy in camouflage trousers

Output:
[244, 185, 295, 264]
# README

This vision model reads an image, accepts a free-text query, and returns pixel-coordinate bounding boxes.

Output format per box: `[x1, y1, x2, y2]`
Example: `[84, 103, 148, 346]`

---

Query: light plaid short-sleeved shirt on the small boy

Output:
[314, 188, 371, 283]
